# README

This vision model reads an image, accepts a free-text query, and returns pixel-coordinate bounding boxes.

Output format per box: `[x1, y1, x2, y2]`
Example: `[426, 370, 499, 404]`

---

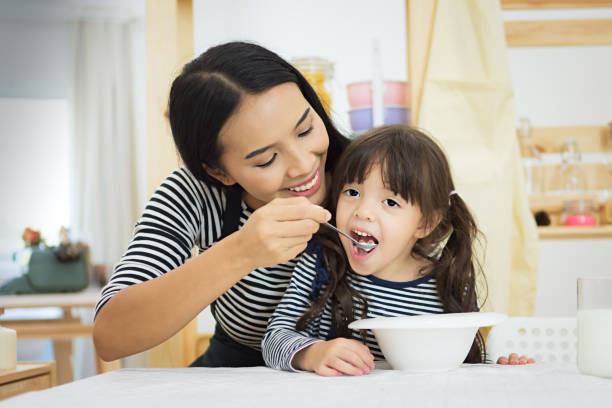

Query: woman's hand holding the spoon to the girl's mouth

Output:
[236, 197, 331, 269]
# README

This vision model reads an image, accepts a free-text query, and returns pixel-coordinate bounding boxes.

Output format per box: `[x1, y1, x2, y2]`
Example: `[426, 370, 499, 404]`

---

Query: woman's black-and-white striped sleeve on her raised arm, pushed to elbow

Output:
[95, 167, 225, 316]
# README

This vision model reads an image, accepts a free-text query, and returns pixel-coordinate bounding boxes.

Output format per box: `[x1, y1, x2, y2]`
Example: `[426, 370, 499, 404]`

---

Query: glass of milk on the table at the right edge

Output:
[577, 276, 612, 378]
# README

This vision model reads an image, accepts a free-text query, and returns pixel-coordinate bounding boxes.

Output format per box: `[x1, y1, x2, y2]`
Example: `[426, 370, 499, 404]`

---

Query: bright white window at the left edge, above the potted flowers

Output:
[0, 98, 70, 280]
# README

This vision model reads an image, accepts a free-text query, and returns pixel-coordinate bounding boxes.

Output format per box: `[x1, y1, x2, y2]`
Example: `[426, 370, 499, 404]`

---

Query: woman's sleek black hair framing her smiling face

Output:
[168, 42, 348, 185]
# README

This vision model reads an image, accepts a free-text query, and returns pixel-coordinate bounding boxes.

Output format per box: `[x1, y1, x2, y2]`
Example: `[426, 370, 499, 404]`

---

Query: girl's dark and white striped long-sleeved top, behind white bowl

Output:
[262, 240, 444, 371]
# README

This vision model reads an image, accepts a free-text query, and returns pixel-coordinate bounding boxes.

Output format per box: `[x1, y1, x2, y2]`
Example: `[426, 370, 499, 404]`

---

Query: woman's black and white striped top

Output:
[96, 167, 297, 350]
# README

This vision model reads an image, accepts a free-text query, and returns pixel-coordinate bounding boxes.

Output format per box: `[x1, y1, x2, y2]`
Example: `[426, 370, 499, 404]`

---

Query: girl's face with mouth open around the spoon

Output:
[336, 166, 425, 282]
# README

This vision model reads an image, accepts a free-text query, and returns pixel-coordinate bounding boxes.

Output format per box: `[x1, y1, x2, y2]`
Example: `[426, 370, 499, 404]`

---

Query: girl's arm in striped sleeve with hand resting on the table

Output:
[262, 247, 374, 376]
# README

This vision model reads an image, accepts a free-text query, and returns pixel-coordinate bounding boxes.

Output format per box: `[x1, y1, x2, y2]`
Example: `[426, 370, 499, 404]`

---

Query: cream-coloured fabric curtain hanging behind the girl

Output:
[415, 0, 538, 316]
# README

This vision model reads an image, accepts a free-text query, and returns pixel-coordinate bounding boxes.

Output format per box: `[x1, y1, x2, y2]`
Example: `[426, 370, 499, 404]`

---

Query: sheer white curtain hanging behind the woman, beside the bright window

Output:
[71, 19, 144, 274]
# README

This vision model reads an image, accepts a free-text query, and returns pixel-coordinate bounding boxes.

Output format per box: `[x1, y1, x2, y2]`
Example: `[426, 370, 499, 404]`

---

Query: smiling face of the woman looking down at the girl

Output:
[207, 82, 329, 209]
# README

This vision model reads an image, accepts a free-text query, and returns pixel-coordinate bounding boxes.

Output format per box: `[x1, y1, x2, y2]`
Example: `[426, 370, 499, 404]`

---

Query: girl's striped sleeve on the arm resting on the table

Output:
[262, 245, 324, 371]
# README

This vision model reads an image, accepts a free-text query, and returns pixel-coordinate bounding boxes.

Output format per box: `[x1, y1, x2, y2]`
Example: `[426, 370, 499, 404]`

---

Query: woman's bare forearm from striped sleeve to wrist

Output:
[93, 233, 253, 361]
